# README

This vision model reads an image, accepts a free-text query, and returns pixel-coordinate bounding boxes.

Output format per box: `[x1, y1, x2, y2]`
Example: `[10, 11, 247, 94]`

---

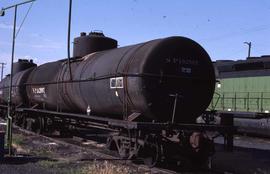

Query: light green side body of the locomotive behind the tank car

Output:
[209, 76, 270, 113]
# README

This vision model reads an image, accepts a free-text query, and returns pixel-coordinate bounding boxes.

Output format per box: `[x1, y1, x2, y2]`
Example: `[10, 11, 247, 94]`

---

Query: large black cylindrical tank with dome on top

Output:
[0, 32, 215, 123]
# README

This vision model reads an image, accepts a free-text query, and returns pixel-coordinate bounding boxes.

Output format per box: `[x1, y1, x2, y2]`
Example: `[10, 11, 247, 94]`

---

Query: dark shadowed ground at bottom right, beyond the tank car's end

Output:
[213, 136, 270, 174]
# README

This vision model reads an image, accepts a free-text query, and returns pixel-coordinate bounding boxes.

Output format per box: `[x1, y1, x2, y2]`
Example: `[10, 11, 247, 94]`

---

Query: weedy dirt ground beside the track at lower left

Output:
[0, 130, 149, 174]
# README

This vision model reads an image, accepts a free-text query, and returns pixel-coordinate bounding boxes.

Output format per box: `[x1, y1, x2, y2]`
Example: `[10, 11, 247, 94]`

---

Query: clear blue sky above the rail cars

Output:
[0, 0, 270, 75]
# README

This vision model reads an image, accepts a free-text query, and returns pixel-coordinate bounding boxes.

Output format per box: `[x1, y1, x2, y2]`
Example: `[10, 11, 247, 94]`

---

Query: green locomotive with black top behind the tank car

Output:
[209, 56, 270, 117]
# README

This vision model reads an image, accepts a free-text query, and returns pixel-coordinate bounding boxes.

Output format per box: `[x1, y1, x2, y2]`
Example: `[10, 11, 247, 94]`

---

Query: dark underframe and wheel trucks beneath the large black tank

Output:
[1, 107, 236, 167]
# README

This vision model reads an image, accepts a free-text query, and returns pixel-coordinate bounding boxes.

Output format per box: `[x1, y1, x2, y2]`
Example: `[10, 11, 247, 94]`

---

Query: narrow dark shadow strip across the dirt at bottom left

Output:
[0, 156, 56, 165]
